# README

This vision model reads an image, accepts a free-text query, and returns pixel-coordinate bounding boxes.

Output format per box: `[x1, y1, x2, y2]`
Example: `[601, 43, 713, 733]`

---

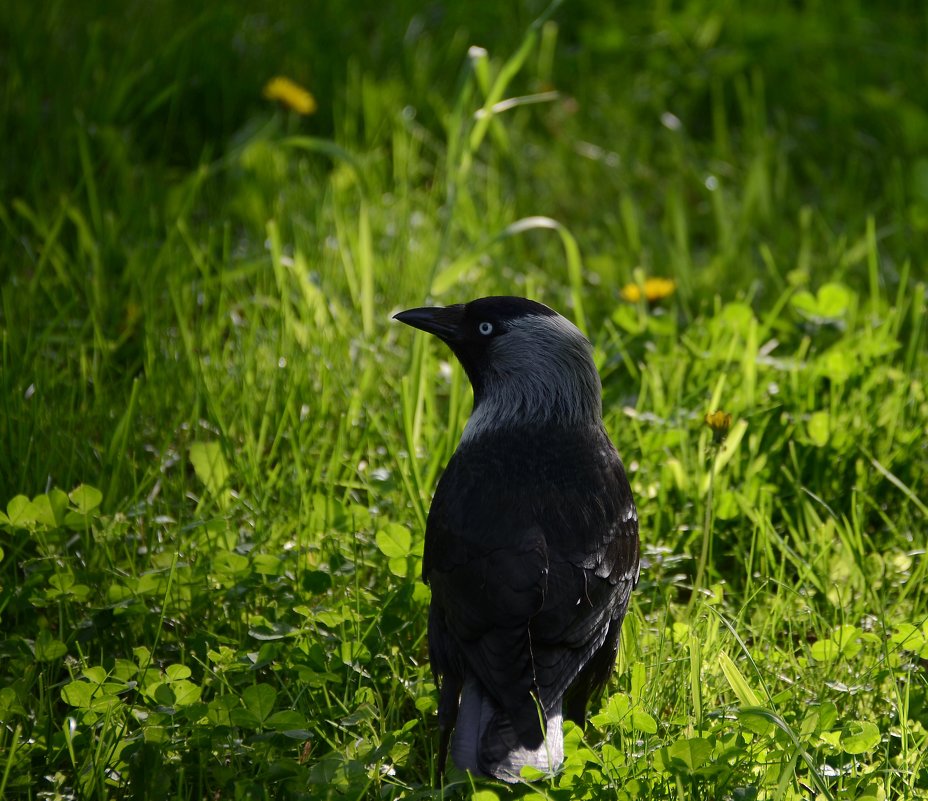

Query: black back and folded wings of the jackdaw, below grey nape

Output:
[423, 428, 638, 746]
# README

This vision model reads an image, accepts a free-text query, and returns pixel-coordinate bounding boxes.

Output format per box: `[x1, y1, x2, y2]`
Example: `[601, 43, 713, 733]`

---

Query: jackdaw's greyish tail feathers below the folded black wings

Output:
[451, 676, 564, 783]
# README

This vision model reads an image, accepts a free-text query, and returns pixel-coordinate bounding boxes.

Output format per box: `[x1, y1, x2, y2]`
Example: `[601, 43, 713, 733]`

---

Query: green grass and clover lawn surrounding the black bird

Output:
[0, 0, 928, 801]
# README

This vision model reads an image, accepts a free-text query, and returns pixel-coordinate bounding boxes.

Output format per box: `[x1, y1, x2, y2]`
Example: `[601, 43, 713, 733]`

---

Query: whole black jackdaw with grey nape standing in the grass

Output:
[394, 296, 639, 783]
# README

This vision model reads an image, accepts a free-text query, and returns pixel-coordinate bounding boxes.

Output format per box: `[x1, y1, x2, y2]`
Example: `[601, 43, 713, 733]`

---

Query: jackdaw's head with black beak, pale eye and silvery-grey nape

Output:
[395, 297, 602, 441]
